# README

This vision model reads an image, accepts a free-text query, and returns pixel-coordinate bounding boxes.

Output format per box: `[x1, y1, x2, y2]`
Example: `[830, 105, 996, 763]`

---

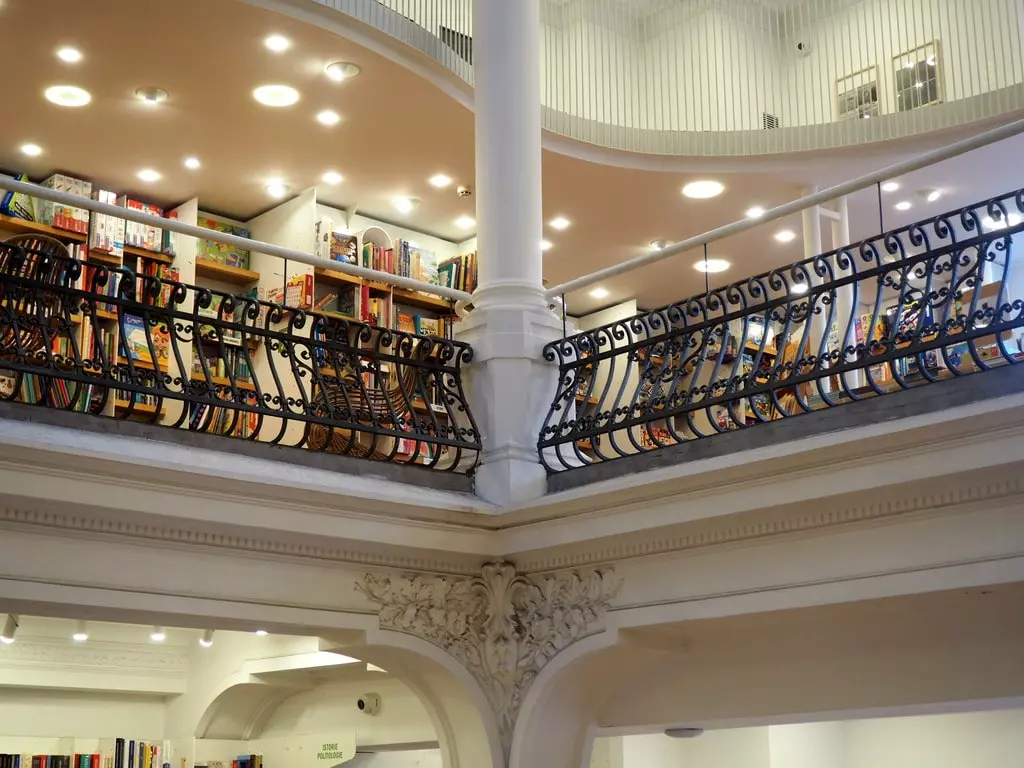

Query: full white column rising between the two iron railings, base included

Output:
[458, 0, 561, 506]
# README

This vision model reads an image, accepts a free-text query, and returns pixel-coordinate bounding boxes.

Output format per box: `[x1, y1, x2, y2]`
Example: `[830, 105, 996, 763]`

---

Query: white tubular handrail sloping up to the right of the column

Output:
[547, 120, 1024, 299]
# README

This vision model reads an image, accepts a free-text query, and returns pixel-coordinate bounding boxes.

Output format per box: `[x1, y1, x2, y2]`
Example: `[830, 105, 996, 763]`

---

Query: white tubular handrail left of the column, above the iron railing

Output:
[0, 176, 472, 301]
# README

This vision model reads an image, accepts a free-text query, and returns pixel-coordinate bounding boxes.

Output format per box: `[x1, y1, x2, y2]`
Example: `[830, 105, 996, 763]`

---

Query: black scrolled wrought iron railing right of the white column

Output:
[539, 189, 1024, 472]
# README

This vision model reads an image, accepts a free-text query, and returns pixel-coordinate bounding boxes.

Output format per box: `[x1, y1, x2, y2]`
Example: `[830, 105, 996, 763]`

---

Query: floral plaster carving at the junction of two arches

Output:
[356, 562, 618, 758]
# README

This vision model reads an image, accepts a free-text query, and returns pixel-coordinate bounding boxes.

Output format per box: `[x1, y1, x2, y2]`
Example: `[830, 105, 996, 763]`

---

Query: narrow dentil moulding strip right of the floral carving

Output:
[516, 474, 1024, 573]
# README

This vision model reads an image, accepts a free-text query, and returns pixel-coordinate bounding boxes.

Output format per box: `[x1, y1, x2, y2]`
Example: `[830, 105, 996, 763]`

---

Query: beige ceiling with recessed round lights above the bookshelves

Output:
[0, 0, 1011, 314]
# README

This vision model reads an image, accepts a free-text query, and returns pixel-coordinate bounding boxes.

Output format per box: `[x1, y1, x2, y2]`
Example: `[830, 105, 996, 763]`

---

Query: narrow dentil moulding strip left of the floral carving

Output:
[0, 507, 479, 574]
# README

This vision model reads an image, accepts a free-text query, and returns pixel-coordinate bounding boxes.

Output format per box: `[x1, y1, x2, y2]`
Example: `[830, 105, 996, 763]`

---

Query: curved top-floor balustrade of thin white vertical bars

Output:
[307, 0, 1024, 156]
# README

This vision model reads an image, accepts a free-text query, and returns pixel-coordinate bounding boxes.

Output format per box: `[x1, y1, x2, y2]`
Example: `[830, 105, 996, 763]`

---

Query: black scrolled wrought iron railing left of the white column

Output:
[0, 236, 480, 472]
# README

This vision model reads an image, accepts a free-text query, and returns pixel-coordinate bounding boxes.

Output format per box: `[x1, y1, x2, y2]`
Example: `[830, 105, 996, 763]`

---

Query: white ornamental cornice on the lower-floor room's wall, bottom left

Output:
[0, 635, 188, 677]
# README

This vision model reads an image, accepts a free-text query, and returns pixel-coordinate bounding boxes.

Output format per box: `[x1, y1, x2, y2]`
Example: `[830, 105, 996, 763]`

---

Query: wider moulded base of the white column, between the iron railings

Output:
[456, 284, 562, 507]
